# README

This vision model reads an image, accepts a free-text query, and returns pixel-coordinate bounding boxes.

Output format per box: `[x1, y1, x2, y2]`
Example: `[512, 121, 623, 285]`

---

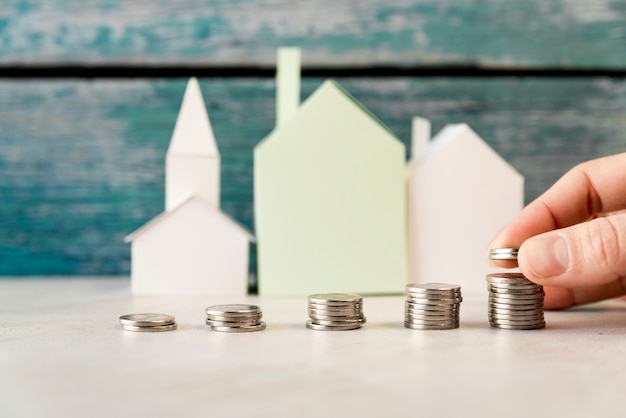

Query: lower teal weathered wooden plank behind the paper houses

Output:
[0, 79, 626, 275]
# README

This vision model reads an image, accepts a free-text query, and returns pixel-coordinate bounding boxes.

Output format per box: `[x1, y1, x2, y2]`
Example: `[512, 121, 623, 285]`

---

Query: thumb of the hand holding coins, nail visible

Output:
[518, 213, 626, 288]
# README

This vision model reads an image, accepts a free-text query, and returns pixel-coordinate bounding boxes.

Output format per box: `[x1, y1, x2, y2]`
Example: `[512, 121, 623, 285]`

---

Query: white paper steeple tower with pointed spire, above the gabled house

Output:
[165, 78, 220, 211]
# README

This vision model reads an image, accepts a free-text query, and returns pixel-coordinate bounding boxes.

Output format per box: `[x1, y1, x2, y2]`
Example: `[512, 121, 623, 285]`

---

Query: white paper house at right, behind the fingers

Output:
[408, 121, 524, 292]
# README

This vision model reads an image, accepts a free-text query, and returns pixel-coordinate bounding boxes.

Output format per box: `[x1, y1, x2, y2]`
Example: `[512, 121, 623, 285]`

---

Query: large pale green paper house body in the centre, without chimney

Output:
[254, 76, 407, 295]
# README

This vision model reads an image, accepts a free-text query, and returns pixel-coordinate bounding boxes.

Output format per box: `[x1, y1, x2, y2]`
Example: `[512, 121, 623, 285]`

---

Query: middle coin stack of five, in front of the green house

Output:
[306, 293, 365, 331]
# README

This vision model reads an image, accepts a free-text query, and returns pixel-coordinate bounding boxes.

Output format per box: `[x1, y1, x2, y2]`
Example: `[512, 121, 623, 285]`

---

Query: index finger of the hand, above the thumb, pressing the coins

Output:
[490, 153, 626, 267]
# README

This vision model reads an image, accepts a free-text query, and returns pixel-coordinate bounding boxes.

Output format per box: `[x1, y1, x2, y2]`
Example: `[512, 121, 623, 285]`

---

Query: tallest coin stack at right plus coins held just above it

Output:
[487, 248, 546, 330]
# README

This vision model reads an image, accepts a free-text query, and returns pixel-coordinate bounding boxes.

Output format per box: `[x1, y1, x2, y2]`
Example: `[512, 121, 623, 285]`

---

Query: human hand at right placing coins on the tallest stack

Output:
[489, 153, 626, 309]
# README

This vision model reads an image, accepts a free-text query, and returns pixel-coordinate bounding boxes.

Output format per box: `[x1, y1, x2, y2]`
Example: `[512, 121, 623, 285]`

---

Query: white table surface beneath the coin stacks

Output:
[0, 278, 626, 418]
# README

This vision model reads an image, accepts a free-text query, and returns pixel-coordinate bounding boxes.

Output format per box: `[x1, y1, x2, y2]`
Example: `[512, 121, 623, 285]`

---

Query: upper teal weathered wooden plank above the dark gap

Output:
[0, 0, 626, 68]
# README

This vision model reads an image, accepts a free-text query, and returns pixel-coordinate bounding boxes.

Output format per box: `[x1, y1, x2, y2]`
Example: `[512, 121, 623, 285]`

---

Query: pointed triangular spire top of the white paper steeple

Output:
[167, 77, 220, 158]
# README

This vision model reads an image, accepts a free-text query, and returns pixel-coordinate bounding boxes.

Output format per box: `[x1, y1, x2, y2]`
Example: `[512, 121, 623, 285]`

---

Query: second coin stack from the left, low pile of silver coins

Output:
[205, 304, 265, 332]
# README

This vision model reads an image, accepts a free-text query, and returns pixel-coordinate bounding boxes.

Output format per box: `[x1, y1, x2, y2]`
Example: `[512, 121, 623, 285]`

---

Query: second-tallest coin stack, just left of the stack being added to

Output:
[404, 283, 463, 330]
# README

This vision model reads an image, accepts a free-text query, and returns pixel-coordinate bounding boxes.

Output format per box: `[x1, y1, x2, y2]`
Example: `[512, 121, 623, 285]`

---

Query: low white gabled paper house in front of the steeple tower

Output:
[126, 196, 252, 296]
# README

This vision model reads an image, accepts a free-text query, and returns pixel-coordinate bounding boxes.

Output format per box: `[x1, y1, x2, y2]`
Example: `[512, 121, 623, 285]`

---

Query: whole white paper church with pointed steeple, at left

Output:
[125, 78, 253, 296]
